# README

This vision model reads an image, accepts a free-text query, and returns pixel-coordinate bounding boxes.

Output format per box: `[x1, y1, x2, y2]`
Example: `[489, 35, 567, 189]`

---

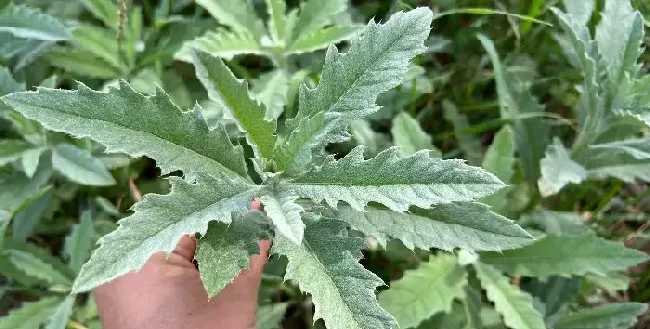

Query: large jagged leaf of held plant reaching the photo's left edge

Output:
[2, 81, 247, 177]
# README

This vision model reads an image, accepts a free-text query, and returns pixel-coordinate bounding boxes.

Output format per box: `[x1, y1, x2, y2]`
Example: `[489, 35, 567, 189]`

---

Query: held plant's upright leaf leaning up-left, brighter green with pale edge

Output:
[192, 51, 275, 159]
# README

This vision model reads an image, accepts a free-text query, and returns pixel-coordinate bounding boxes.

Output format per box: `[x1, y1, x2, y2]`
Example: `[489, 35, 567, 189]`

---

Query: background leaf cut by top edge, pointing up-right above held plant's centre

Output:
[290, 0, 347, 42]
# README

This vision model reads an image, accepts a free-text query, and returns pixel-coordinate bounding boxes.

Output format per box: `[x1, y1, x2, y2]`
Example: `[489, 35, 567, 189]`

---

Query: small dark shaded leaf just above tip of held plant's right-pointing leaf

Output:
[442, 100, 482, 165]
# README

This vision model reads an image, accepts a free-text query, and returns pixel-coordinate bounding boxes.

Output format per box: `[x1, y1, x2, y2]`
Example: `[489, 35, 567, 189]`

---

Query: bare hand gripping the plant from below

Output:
[94, 200, 271, 329]
